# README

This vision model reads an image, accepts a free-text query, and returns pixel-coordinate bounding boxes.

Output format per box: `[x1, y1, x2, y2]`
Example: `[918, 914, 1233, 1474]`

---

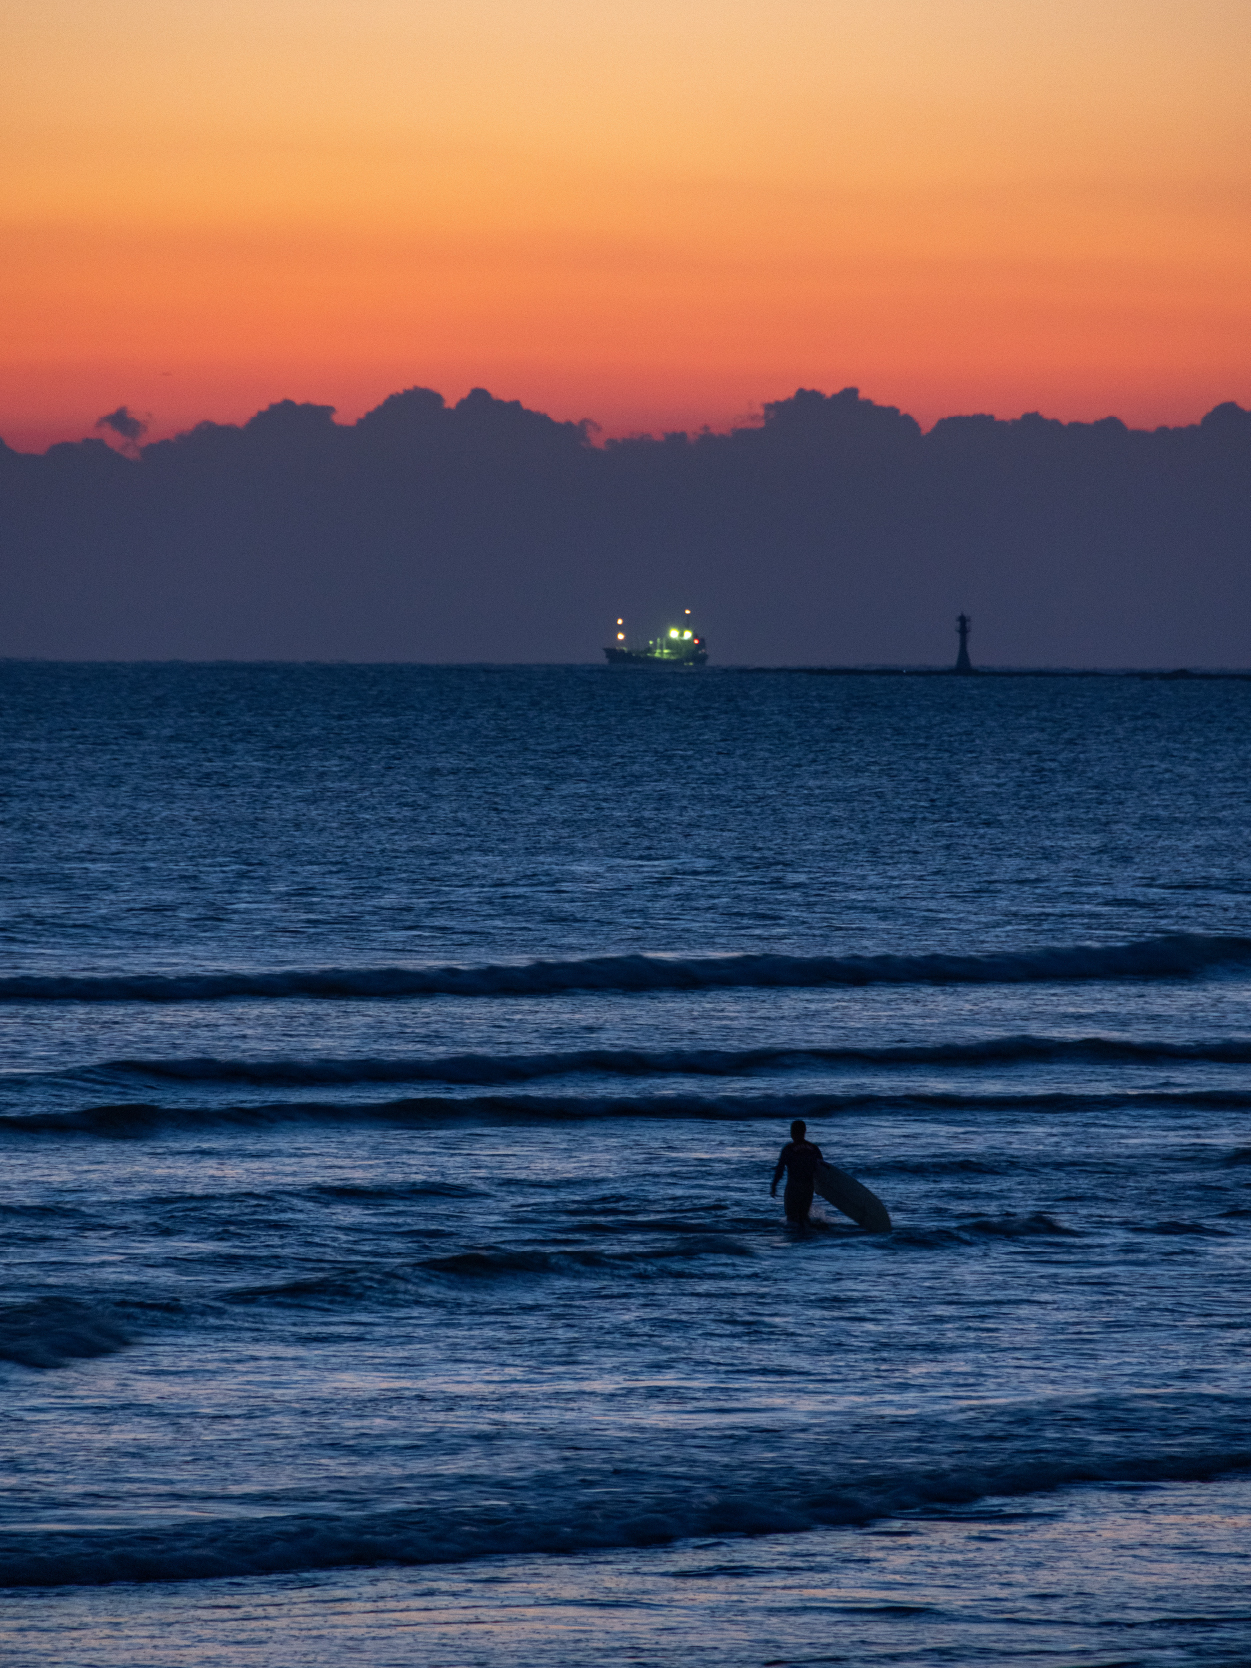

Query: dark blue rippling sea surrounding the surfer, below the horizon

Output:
[0, 662, 1251, 1668]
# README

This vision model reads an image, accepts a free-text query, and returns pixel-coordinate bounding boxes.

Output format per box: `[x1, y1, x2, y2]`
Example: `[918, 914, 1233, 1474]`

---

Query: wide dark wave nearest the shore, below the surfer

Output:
[0, 1394, 1251, 1588]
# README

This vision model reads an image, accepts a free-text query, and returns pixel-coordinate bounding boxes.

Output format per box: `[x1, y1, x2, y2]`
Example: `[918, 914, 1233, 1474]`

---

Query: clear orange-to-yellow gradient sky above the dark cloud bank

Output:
[0, 0, 1251, 449]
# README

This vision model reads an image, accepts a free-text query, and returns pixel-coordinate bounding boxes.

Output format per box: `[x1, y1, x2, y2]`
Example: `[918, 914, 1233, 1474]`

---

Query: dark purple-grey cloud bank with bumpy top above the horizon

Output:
[0, 389, 1251, 667]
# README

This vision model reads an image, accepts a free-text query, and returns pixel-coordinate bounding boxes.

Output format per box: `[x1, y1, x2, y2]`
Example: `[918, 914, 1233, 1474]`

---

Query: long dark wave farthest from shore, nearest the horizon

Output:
[0, 932, 1251, 1002]
